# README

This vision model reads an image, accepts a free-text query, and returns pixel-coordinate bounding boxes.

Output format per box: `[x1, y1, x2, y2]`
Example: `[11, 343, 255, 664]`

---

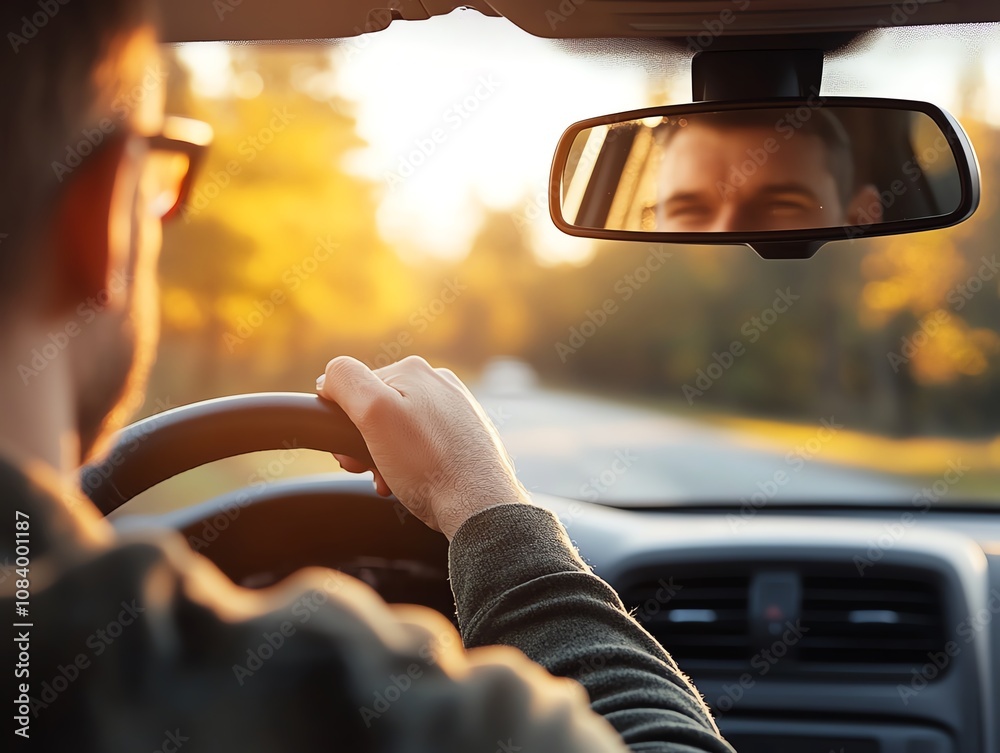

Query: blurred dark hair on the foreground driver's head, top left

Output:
[0, 0, 155, 295]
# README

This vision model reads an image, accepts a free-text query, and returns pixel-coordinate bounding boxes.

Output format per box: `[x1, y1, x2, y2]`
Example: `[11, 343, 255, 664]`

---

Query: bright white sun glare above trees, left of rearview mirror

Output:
[331, 12, 648, 262]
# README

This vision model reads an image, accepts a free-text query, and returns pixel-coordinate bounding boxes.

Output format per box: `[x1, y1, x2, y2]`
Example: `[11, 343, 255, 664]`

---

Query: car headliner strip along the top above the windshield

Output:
[161, 0, 1000, 49]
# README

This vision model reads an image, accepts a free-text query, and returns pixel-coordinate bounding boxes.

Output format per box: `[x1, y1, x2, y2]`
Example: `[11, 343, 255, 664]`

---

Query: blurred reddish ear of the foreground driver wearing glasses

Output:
[49, 138, 125, 314]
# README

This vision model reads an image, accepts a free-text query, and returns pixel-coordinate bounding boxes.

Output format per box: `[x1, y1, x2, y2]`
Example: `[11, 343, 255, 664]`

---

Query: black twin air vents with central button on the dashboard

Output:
[621, 561, 948, 676]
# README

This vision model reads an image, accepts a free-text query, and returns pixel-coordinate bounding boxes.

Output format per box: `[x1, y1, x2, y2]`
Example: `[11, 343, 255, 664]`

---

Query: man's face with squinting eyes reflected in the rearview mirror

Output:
[656, 113, 881, 233]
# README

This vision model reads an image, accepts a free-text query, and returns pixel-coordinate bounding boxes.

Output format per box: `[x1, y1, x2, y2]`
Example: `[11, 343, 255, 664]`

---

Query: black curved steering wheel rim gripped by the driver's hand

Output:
[80, 392, 374, 515]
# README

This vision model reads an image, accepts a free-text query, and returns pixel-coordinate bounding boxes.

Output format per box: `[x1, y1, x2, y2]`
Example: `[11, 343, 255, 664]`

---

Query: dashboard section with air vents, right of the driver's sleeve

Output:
[546, 500, 1000, 753]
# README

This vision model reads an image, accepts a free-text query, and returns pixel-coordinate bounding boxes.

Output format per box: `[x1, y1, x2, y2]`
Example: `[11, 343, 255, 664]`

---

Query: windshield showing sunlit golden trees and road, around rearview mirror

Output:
[131, 12, 1000, 507]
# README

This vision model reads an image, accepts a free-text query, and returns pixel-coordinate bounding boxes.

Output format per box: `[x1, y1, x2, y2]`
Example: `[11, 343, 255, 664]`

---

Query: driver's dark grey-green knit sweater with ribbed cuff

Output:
[0, 461, 731, 753]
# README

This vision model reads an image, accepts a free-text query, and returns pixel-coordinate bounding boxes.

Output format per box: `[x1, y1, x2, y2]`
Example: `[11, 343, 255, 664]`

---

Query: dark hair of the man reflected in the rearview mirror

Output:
[656, 106, 856, 207]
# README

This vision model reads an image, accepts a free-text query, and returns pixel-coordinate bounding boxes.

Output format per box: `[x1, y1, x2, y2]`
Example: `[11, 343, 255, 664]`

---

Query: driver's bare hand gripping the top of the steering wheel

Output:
[316, 356, 530, 540]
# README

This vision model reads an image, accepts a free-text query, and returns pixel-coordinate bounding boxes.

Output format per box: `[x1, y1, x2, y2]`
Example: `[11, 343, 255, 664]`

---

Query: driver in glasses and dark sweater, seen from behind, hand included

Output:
[0, 0, 732, 753]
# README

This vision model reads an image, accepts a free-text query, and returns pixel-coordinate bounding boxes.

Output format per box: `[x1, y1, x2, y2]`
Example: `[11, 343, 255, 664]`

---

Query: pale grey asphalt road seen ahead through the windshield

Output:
[475, 388, 918, 506]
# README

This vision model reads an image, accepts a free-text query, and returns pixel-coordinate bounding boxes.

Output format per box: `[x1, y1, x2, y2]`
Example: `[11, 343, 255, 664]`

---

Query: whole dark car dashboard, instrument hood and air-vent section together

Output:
[115, 474, 1000, 753]
